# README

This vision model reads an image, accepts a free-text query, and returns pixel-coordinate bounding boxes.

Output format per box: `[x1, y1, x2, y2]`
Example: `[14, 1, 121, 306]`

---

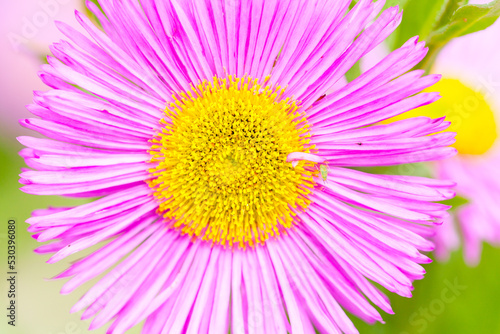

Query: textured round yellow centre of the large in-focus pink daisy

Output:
[150, 77, 317, 248]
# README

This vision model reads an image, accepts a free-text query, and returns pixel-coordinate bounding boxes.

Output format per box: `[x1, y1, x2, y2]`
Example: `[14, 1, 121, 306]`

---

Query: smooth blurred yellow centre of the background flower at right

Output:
[391, 79, 498, 155]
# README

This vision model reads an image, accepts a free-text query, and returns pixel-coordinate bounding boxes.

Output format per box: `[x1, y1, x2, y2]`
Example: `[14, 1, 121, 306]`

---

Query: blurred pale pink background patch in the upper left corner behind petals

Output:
[0, 0, 83, 145]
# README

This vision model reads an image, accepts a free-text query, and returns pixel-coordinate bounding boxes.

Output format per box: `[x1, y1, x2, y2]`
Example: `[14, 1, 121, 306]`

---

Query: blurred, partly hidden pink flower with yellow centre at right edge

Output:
[390, 5, 500, 265]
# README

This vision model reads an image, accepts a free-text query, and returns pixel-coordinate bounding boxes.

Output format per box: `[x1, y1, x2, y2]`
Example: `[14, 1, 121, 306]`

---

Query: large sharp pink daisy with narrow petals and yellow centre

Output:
[19, 0, 455, 334]
